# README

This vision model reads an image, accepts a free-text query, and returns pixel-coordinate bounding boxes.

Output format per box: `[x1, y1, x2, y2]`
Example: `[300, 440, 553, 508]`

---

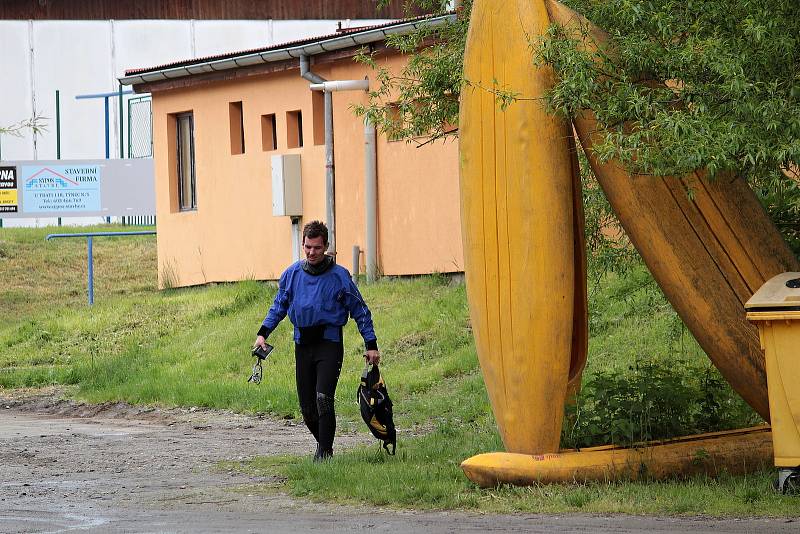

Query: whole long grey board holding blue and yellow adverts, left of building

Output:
[0, 158, 156, 219]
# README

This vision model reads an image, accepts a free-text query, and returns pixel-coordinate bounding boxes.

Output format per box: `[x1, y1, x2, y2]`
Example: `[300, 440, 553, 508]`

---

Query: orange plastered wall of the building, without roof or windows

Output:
[153, 56, 463, 286]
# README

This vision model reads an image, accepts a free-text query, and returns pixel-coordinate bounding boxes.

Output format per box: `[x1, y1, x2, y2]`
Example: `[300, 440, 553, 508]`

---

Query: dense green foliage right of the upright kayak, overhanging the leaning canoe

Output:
[534, 0, 800, 252]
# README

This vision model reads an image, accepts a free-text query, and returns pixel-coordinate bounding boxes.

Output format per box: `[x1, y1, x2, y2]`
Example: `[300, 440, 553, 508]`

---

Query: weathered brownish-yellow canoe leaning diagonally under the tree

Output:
[547, 0, 800, 421]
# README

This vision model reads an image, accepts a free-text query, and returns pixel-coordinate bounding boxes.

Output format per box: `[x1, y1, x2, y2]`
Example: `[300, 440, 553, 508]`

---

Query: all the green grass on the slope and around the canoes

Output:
[0, 229, 800, 515]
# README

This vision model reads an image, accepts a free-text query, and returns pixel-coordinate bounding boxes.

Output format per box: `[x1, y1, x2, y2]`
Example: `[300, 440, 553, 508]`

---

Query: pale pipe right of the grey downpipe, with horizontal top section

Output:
[310, 78, 378, 282]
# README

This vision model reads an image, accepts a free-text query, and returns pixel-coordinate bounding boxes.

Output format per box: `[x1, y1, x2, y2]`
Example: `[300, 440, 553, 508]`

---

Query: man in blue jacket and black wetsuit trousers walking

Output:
[255, 221, 380, 461]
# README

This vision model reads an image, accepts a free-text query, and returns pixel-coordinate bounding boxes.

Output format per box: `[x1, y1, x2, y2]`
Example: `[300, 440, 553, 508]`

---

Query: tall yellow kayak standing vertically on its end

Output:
[459, 0, 587, 454]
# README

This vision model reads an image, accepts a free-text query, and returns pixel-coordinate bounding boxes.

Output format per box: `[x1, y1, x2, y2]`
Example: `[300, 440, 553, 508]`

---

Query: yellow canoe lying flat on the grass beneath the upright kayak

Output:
[461, 426, 773, 488]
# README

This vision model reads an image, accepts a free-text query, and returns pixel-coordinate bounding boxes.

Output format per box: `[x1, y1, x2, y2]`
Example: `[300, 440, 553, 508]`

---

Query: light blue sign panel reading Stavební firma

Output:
[20, 165, 101, 213]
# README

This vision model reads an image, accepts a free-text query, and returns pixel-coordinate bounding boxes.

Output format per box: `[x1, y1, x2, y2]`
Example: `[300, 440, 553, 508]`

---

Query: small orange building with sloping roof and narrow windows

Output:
[120, 16, 463, 287]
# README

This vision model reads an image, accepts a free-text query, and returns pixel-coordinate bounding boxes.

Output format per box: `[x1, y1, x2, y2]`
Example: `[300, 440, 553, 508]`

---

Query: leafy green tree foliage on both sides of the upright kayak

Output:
[364, 0, 800, 256]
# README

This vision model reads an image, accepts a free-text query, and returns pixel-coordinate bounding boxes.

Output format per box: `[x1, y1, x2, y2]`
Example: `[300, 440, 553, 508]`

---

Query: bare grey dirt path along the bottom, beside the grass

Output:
[0, 395, 797, 533]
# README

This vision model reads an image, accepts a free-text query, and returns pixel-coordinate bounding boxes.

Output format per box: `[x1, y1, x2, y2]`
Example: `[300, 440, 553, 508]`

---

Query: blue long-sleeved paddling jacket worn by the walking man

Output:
[258, 261, 378, 350]
